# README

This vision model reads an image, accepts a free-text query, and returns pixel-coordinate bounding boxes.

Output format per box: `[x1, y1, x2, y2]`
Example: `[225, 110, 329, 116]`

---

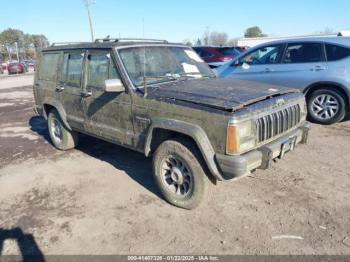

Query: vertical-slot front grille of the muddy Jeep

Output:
[256, 105, 301, 143]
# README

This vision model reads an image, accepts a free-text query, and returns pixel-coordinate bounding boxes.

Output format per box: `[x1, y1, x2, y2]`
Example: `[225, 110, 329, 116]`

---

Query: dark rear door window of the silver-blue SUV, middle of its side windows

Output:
[283, 43, 323, 64]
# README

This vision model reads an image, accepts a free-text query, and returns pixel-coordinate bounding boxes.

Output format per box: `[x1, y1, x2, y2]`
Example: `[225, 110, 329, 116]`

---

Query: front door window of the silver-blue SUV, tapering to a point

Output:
[241, 45, 283, 65]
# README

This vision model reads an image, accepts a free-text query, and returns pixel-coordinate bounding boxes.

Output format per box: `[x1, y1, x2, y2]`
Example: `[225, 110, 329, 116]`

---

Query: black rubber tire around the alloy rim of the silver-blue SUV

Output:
[307, 88, 346, 125]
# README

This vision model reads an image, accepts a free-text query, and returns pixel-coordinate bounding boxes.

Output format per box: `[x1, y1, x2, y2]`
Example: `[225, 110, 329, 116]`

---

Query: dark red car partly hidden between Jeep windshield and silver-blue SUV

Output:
[193, 46, 241, 68]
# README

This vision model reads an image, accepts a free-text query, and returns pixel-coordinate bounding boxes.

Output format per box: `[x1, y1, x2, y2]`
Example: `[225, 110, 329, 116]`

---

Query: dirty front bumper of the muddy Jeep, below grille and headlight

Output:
[215, 122, 310, 180]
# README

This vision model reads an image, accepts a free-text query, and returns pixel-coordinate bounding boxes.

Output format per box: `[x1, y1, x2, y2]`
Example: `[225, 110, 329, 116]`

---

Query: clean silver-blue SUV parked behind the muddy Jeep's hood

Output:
[217, 37, 350, 124]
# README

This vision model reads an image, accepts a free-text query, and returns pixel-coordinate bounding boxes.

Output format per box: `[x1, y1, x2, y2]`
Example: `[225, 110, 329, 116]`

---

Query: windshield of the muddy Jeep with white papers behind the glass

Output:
[119, 46, 215, 87]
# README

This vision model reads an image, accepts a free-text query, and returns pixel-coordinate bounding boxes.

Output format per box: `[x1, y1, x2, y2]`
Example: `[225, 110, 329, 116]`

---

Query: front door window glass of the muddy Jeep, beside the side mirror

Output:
[87, 53, 120, 88]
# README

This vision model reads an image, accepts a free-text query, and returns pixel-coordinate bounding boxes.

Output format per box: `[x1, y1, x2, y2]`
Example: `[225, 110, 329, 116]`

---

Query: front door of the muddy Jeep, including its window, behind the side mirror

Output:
[83, 50, 134, 145]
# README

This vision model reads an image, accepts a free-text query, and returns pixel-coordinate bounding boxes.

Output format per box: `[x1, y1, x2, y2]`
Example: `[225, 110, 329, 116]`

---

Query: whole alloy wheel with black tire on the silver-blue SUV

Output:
[308, 89, 346, 125]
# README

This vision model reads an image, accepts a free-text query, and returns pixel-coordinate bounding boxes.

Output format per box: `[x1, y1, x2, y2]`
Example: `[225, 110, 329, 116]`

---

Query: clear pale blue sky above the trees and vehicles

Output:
[0, 0, 350, 42]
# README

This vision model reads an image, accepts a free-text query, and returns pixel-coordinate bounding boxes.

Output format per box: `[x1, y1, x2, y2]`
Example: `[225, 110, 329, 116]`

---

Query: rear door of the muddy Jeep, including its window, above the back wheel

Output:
[56, 50, 85, 131]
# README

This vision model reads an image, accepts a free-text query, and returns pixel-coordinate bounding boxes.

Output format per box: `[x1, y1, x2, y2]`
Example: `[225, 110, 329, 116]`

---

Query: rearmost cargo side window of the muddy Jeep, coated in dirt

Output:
[39, 53, 60, 81]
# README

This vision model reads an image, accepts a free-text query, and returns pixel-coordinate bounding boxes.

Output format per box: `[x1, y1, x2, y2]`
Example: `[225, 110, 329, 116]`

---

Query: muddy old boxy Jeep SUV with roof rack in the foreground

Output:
[34, 39, 309, 209]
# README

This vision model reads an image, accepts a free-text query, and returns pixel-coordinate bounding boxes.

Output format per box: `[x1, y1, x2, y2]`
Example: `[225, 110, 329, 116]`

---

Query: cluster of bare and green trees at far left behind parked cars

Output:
[0, 28, 49, 61]
